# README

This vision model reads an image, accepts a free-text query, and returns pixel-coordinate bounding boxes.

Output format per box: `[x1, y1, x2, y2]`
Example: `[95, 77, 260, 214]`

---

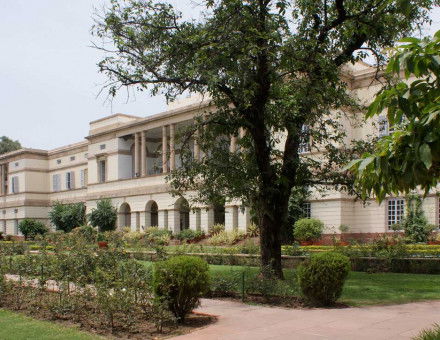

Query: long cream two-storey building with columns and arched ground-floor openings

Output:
[0, 63, 439, 236]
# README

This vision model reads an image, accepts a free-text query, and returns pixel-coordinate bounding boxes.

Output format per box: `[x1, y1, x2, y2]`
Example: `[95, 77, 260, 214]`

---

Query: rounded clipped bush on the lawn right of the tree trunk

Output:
[297, 252, 350, 306]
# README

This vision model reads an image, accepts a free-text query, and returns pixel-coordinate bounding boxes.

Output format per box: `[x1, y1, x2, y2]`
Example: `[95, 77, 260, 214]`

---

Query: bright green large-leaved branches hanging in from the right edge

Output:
[347, 31, 440, 201]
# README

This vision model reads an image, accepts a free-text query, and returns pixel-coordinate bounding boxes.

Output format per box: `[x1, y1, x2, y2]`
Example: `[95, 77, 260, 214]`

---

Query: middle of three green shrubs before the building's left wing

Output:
[49, 202, 86, 233]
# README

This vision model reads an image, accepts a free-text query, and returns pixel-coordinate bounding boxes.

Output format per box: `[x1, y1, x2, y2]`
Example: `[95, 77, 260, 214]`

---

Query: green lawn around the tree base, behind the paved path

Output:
[145, 262, 440, 306]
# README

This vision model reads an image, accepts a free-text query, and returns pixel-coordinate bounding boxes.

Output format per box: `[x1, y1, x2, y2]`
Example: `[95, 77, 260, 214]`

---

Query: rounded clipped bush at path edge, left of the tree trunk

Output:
[153, 256, 209, 322]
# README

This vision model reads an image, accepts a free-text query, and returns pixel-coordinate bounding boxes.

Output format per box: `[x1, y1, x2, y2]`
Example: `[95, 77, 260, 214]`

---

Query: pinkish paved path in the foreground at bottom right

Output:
[173, 299, 440, 340]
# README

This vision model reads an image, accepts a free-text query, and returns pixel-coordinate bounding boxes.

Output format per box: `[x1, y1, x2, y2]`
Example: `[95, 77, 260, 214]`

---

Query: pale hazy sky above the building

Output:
[0, 0, 440, 150]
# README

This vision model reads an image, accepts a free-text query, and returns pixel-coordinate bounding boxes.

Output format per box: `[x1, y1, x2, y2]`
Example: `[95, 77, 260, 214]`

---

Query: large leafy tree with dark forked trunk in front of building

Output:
[93, 0, 435, 277]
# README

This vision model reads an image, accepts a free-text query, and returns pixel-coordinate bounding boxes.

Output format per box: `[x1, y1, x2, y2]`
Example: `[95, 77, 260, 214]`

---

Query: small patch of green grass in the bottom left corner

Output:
[0, 309, 104, 340]
